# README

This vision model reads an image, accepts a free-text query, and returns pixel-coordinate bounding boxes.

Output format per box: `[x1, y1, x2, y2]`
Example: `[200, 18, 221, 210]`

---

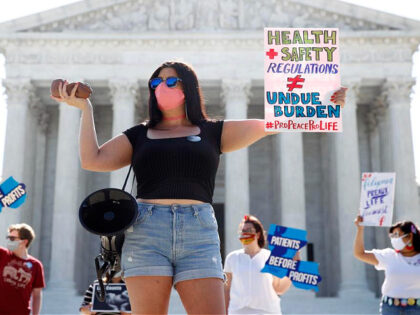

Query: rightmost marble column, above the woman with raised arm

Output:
[384, 78, 420, 224]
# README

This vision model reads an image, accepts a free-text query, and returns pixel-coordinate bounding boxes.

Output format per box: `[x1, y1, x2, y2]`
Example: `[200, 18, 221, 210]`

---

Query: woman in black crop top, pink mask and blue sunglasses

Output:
[51, 62, 345, 314]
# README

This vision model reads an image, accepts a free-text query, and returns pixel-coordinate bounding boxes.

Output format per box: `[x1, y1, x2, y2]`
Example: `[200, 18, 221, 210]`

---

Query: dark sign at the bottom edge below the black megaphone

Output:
[92, 283, 131, 313]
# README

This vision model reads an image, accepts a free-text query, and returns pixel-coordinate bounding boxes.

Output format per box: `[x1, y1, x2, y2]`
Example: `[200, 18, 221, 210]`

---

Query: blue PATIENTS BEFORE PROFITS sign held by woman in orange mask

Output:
[261, 224, 322, 291]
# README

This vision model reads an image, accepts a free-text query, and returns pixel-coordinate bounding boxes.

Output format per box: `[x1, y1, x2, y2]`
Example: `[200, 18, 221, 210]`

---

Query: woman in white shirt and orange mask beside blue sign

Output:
[224, 215, 296, 314]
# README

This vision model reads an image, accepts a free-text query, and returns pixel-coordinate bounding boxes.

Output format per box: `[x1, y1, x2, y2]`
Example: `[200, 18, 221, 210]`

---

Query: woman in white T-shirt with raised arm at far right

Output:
[354, 216, 420, 315]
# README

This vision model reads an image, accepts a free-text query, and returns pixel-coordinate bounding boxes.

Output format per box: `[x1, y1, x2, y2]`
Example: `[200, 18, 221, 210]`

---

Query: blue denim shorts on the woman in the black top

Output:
[121, 202, 224, 285]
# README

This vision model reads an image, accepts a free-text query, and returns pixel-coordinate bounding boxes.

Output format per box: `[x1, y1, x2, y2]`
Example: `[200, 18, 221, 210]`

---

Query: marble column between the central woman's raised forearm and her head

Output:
[109, 79, 138, 188]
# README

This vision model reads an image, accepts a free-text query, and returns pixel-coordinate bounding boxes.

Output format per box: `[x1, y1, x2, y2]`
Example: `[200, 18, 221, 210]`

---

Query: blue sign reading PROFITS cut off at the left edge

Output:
[0, 176, 26, 212]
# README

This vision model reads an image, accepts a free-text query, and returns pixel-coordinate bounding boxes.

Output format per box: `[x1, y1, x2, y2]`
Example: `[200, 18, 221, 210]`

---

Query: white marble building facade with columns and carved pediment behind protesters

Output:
[0, 0, 420, 296]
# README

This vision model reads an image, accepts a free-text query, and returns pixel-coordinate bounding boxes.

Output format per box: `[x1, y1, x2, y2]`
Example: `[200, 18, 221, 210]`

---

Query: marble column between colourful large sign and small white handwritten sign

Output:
[334, 79, 367, 296]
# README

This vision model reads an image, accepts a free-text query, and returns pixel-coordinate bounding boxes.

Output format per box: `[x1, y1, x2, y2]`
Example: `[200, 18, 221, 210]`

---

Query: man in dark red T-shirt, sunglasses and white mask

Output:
[0, 223, 45, 315]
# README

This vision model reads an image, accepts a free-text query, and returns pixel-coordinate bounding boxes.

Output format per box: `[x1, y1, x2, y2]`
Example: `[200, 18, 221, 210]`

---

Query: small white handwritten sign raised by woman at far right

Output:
[360, 173, 395, 226]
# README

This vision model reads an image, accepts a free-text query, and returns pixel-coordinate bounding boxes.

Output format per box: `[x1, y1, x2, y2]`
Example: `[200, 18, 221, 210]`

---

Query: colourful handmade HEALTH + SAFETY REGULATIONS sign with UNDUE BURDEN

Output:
[264, 28, 342, 132]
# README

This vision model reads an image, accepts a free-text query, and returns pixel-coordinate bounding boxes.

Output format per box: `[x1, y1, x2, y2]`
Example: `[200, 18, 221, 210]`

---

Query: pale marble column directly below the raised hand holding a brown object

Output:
[49, 103, 81, 294]
